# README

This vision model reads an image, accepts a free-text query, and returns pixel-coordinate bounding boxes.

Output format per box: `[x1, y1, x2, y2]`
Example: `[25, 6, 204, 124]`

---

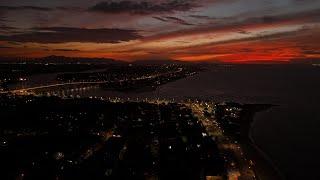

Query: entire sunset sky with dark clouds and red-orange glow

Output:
[0, 0, 320, 63]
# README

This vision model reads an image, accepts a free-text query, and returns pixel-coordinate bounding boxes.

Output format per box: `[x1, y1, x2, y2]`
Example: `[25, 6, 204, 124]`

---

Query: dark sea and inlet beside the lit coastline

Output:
[83, 65, 320, 179]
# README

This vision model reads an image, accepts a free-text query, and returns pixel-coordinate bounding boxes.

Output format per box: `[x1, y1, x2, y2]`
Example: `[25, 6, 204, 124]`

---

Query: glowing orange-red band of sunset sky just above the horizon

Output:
[0, 21, 320, 63]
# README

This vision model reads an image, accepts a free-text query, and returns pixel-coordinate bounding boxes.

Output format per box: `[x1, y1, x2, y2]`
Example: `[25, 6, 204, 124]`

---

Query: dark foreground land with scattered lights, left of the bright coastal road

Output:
[0, 95, 226, 180]
